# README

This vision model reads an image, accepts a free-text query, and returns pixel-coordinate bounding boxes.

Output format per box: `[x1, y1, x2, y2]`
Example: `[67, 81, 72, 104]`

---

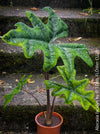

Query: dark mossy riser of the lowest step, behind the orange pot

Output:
[0, 106, 96, 131]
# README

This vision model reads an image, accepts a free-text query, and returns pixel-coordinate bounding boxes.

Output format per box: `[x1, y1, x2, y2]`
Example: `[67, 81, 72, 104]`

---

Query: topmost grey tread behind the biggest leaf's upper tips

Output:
[0, 7, 100, 19]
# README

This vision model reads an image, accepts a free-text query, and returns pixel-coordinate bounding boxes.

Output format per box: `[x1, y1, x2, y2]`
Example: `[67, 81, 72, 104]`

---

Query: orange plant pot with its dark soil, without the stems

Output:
[35, 112, 63, 134]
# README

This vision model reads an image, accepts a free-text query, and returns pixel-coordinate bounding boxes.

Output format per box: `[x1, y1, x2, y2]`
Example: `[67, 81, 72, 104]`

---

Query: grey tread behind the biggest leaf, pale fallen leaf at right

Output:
[0, 37, 100, 54]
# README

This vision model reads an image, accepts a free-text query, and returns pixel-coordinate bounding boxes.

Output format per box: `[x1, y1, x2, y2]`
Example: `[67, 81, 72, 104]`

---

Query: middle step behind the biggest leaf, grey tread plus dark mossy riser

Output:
[0, 38, 100, 73]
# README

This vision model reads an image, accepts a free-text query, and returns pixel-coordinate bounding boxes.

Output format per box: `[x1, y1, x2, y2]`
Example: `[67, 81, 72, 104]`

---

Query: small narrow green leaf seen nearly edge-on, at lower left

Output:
[4, 75, 32, 108]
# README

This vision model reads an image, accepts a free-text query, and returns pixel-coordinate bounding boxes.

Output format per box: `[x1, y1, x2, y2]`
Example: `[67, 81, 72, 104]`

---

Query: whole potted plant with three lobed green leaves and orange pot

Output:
[2, 7, 99, 134]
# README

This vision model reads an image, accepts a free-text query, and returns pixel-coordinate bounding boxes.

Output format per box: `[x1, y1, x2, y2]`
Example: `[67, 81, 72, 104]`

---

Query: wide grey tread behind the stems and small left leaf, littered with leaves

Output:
[0, 74, 95, 105]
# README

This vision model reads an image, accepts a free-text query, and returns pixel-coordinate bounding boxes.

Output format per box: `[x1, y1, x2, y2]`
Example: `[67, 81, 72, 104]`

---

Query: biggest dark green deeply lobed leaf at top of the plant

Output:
[2, 7, 93, 72]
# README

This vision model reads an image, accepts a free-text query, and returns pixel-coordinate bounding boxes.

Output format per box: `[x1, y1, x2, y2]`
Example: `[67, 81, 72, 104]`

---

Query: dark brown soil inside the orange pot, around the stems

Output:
[37, 115, 61, 127]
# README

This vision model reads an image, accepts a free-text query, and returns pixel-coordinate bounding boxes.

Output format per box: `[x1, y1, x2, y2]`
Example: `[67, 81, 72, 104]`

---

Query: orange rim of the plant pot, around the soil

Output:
[35, 111, 63, 128]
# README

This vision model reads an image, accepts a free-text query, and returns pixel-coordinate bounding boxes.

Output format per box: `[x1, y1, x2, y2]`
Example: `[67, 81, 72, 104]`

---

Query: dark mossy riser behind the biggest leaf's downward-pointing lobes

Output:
[0, 53, 100, 74]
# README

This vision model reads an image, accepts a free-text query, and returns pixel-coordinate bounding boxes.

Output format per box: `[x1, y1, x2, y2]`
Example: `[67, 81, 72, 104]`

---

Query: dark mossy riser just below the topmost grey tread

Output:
[0, 13, 100, 37]
